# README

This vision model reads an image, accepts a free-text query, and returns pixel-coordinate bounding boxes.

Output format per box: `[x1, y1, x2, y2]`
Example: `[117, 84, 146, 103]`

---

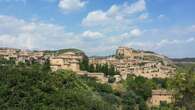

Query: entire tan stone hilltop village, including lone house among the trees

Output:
[0, 47, 175, 106]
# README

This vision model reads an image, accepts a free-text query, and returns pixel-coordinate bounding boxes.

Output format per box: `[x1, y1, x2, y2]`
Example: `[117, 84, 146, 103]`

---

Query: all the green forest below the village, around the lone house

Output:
[0, 59, 195, 110]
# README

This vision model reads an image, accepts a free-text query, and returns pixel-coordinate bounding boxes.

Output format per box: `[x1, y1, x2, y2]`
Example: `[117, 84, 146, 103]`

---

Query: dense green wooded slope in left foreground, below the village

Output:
[0, 61, 117, 110]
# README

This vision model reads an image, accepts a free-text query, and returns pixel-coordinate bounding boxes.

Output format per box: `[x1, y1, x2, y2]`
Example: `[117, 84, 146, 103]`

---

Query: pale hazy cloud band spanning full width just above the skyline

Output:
[0, 15, 195, 57]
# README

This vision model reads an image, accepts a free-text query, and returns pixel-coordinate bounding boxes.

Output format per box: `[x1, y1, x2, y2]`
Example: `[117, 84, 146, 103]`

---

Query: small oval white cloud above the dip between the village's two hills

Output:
[82, 30, 103, 39]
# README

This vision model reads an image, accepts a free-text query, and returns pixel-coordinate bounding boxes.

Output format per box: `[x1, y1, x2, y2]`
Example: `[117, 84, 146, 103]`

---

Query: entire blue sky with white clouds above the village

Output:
[0, 0, 195, 58]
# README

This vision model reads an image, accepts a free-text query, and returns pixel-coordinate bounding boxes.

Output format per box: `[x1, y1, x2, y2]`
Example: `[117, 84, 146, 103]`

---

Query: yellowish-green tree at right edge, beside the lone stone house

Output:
[168, 68, 195, 110]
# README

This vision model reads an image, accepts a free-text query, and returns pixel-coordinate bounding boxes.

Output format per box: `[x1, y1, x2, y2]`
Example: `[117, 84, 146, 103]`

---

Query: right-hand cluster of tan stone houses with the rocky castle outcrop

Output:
[89, 47, 175, 79]
